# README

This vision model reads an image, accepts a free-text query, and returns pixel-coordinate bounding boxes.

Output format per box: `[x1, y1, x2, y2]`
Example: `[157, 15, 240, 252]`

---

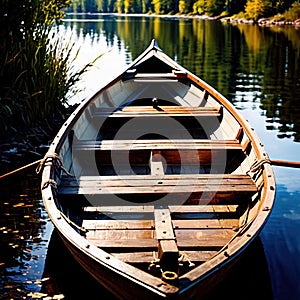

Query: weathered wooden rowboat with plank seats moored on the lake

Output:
[41, 40, 275, 299]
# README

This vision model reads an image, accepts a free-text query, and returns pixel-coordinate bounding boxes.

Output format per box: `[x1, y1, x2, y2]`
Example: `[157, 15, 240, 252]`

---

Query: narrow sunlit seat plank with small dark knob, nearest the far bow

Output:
[93, 106, 222, 119]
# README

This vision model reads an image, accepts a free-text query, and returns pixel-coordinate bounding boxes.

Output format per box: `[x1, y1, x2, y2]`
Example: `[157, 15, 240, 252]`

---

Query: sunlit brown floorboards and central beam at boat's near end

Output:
[82, 205, 238, 264]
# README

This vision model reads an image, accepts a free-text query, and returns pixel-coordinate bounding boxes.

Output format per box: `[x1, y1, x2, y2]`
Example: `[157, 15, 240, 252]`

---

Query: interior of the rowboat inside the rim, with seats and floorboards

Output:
[54, 65, 263, 281]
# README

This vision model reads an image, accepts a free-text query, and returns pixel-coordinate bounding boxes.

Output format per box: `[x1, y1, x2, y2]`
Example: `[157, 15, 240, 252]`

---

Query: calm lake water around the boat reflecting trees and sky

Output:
[0, 15, 300, 299]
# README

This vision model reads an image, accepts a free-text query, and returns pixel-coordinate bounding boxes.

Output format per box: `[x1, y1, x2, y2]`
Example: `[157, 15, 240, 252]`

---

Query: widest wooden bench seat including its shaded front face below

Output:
[58, 174, 257, 205]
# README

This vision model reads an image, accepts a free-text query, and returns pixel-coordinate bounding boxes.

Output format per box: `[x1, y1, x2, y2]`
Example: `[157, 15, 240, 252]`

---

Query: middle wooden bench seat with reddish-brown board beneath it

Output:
[73, 139, 245, 171]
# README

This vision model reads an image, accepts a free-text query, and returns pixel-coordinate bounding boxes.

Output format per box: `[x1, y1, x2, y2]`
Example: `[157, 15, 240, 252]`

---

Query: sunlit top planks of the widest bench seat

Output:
[58, 174, 257, 195]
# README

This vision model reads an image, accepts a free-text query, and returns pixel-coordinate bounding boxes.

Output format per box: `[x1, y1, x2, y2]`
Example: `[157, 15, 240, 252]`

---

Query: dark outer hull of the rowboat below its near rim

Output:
[59, 227, 263, 300]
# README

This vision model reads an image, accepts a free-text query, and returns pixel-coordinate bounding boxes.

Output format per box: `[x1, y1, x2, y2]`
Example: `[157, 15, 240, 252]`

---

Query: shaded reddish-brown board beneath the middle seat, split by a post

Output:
[74, 149, 244, 170]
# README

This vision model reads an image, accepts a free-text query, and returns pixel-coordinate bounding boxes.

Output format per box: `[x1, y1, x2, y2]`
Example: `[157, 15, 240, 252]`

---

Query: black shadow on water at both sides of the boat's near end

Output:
[42, 230, 273, 300]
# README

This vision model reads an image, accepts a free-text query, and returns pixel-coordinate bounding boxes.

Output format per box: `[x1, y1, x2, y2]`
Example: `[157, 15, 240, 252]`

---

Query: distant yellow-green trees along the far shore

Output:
[67, 0, 300, 19]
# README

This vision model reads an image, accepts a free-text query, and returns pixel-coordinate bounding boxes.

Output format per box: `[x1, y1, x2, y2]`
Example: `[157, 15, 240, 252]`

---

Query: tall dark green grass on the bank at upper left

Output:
[0, 0, 90, 137]
